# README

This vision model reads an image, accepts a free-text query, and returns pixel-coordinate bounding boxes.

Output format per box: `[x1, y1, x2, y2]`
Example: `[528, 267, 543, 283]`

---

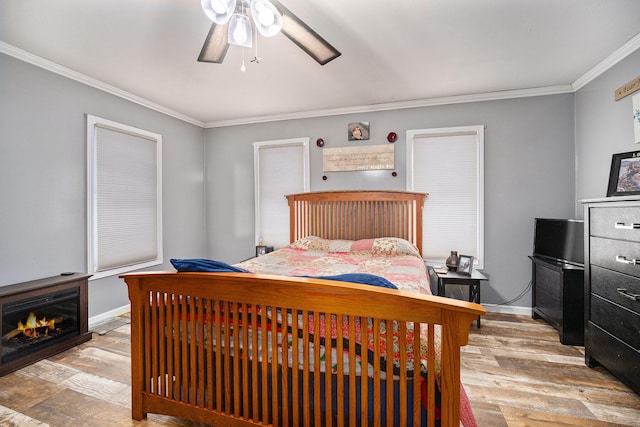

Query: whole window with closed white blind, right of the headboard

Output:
[407, 126, 484, 269]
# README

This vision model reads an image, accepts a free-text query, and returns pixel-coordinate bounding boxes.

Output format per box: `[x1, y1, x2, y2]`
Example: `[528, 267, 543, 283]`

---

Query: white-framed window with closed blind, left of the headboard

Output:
[253, 138, 309, 249]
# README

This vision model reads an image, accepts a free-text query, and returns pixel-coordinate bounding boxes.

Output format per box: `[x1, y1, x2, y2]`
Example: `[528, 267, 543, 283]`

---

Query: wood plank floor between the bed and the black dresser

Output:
[461, 313, 640, 427]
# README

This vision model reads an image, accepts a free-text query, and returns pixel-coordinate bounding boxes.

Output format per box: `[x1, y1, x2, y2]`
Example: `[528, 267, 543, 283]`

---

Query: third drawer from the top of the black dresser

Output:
[591, 266, 640, 314]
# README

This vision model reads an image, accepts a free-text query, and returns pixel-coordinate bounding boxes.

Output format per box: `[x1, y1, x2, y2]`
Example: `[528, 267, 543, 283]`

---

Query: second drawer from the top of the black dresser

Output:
[589, 237, 640, 277]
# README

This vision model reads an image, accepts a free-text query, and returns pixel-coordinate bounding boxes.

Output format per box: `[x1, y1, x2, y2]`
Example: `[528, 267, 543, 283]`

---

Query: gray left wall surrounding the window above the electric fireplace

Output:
[0, 54, 205, 317]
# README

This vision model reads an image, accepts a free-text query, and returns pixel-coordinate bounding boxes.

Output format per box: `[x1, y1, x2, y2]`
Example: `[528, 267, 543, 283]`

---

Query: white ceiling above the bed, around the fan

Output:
[0, 0, 640, 126]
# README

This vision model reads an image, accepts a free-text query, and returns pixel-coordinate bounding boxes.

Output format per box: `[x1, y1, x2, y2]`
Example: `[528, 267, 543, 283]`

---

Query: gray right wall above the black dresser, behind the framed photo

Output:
[575, 50, 640, 206]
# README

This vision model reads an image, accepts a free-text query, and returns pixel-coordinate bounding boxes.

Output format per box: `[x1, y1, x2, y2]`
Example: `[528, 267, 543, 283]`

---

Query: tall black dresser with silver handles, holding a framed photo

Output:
[583, 197, 640, 393]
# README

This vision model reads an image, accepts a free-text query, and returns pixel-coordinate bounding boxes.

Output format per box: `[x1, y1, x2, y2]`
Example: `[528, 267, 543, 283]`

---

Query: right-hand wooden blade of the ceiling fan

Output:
[271, 0, 342, 65]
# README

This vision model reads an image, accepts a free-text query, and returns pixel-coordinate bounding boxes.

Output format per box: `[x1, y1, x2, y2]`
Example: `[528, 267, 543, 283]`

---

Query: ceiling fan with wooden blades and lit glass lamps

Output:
[198, 0, 341, 65]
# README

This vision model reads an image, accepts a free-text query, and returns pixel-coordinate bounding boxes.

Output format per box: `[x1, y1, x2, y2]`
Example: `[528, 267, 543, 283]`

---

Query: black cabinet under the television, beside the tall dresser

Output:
[529, 256, 584, 345]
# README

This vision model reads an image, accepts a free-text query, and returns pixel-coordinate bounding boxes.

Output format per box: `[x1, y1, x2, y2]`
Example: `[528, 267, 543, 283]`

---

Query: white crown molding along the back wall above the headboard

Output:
[204, 85, 574, 128]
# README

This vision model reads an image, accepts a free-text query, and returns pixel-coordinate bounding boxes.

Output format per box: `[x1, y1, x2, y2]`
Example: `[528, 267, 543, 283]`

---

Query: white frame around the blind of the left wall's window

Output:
[87, 114, 163, 280]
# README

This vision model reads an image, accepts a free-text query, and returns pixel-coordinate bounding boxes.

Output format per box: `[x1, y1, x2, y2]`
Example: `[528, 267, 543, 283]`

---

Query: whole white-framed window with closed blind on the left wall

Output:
[87, 115, 162, 279]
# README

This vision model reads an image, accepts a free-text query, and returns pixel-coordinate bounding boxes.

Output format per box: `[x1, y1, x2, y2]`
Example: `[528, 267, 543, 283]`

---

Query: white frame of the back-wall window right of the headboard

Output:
[406, 125, 485, 270]
